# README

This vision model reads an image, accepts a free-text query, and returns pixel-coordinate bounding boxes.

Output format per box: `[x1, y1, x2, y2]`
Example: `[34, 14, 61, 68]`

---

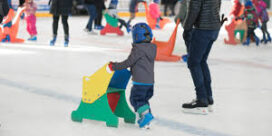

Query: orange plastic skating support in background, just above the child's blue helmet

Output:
[142, 2, 171, 29]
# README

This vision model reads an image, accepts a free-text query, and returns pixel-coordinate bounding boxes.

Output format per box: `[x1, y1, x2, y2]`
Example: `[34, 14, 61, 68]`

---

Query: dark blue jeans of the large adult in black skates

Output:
[187, 29, 219, 103]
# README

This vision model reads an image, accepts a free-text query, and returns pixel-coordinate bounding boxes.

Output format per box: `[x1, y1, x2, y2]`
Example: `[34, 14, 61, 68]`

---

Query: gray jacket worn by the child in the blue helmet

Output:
[112, 43, 157, 84]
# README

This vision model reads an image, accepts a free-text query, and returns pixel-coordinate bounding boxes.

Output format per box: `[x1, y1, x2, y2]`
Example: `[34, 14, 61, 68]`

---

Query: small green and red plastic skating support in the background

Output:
[100, 13, 124, 36]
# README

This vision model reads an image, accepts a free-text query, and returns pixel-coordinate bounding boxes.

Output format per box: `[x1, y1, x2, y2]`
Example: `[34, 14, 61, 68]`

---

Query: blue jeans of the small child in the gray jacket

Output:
[130, 85, 154, 112]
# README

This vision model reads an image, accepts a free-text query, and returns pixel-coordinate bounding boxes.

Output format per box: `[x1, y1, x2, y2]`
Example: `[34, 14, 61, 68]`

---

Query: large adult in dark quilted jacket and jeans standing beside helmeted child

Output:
[182, 0, 221, 114]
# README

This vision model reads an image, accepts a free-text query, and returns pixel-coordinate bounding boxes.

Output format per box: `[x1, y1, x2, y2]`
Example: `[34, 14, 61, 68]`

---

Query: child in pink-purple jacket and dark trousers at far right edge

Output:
[256, 0, 271, 44]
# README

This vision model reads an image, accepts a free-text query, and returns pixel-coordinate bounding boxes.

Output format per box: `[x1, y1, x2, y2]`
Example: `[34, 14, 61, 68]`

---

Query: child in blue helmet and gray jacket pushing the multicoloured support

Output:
[109, 23, 156, 128]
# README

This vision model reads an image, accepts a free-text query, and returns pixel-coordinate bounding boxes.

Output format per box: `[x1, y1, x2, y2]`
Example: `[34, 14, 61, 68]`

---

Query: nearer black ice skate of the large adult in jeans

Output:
[182, 100, 208, 115]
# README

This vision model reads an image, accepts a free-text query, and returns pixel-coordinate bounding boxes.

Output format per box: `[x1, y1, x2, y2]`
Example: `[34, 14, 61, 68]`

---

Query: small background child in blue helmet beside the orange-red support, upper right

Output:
[239, 0, 260, 46]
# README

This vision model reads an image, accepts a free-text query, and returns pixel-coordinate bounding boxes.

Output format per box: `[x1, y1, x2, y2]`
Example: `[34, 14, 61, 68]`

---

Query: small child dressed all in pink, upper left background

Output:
[24, 0, 37, 41]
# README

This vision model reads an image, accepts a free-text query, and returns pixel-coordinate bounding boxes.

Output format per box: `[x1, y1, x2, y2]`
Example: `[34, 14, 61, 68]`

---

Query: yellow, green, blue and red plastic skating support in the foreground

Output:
[71, 64, 136, 127]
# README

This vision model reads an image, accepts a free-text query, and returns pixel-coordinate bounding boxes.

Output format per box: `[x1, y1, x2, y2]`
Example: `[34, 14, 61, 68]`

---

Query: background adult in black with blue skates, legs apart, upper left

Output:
[49, 0, 73, 47]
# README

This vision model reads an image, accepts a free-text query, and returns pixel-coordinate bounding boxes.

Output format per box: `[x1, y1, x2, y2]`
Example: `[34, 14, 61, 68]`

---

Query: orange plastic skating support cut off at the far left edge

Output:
[0, 8, 25, 43]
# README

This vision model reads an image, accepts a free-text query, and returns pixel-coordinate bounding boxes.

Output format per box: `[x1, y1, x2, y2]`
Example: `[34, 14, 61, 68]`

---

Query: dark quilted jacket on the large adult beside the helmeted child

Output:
[183, 0, 221, 30]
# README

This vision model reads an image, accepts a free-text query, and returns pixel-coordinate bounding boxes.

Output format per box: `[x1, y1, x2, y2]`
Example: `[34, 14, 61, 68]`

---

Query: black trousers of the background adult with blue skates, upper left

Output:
[53, 15, 69, 36]
